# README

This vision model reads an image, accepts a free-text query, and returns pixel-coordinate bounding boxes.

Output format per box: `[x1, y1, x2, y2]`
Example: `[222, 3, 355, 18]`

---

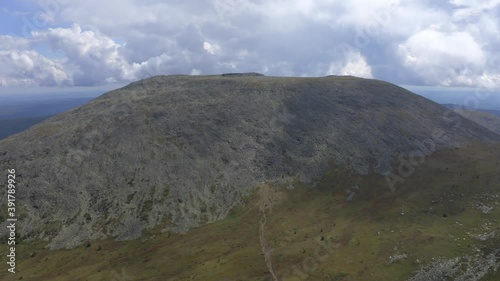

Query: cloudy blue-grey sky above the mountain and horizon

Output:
[0, 0, 500, 106]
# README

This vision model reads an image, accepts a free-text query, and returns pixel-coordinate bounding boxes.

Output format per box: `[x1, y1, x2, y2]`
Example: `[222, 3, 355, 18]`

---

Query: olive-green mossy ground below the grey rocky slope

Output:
[0, 144, 500, 281]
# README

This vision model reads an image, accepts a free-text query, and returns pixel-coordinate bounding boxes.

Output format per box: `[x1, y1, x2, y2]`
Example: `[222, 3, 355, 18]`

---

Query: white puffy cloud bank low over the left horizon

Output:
[2, 24, 184, 86]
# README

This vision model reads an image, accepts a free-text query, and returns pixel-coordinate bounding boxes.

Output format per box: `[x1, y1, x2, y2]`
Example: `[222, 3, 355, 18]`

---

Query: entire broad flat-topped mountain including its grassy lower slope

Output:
[0, 73, 500, 281]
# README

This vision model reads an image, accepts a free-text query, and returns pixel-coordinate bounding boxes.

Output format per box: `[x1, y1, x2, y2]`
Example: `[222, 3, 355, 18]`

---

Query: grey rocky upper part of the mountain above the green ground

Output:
[0, 73, 499, 249]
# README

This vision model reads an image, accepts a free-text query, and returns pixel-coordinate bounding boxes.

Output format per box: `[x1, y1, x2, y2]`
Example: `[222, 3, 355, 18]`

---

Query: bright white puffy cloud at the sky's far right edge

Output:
[397, 0, 500, 87]
